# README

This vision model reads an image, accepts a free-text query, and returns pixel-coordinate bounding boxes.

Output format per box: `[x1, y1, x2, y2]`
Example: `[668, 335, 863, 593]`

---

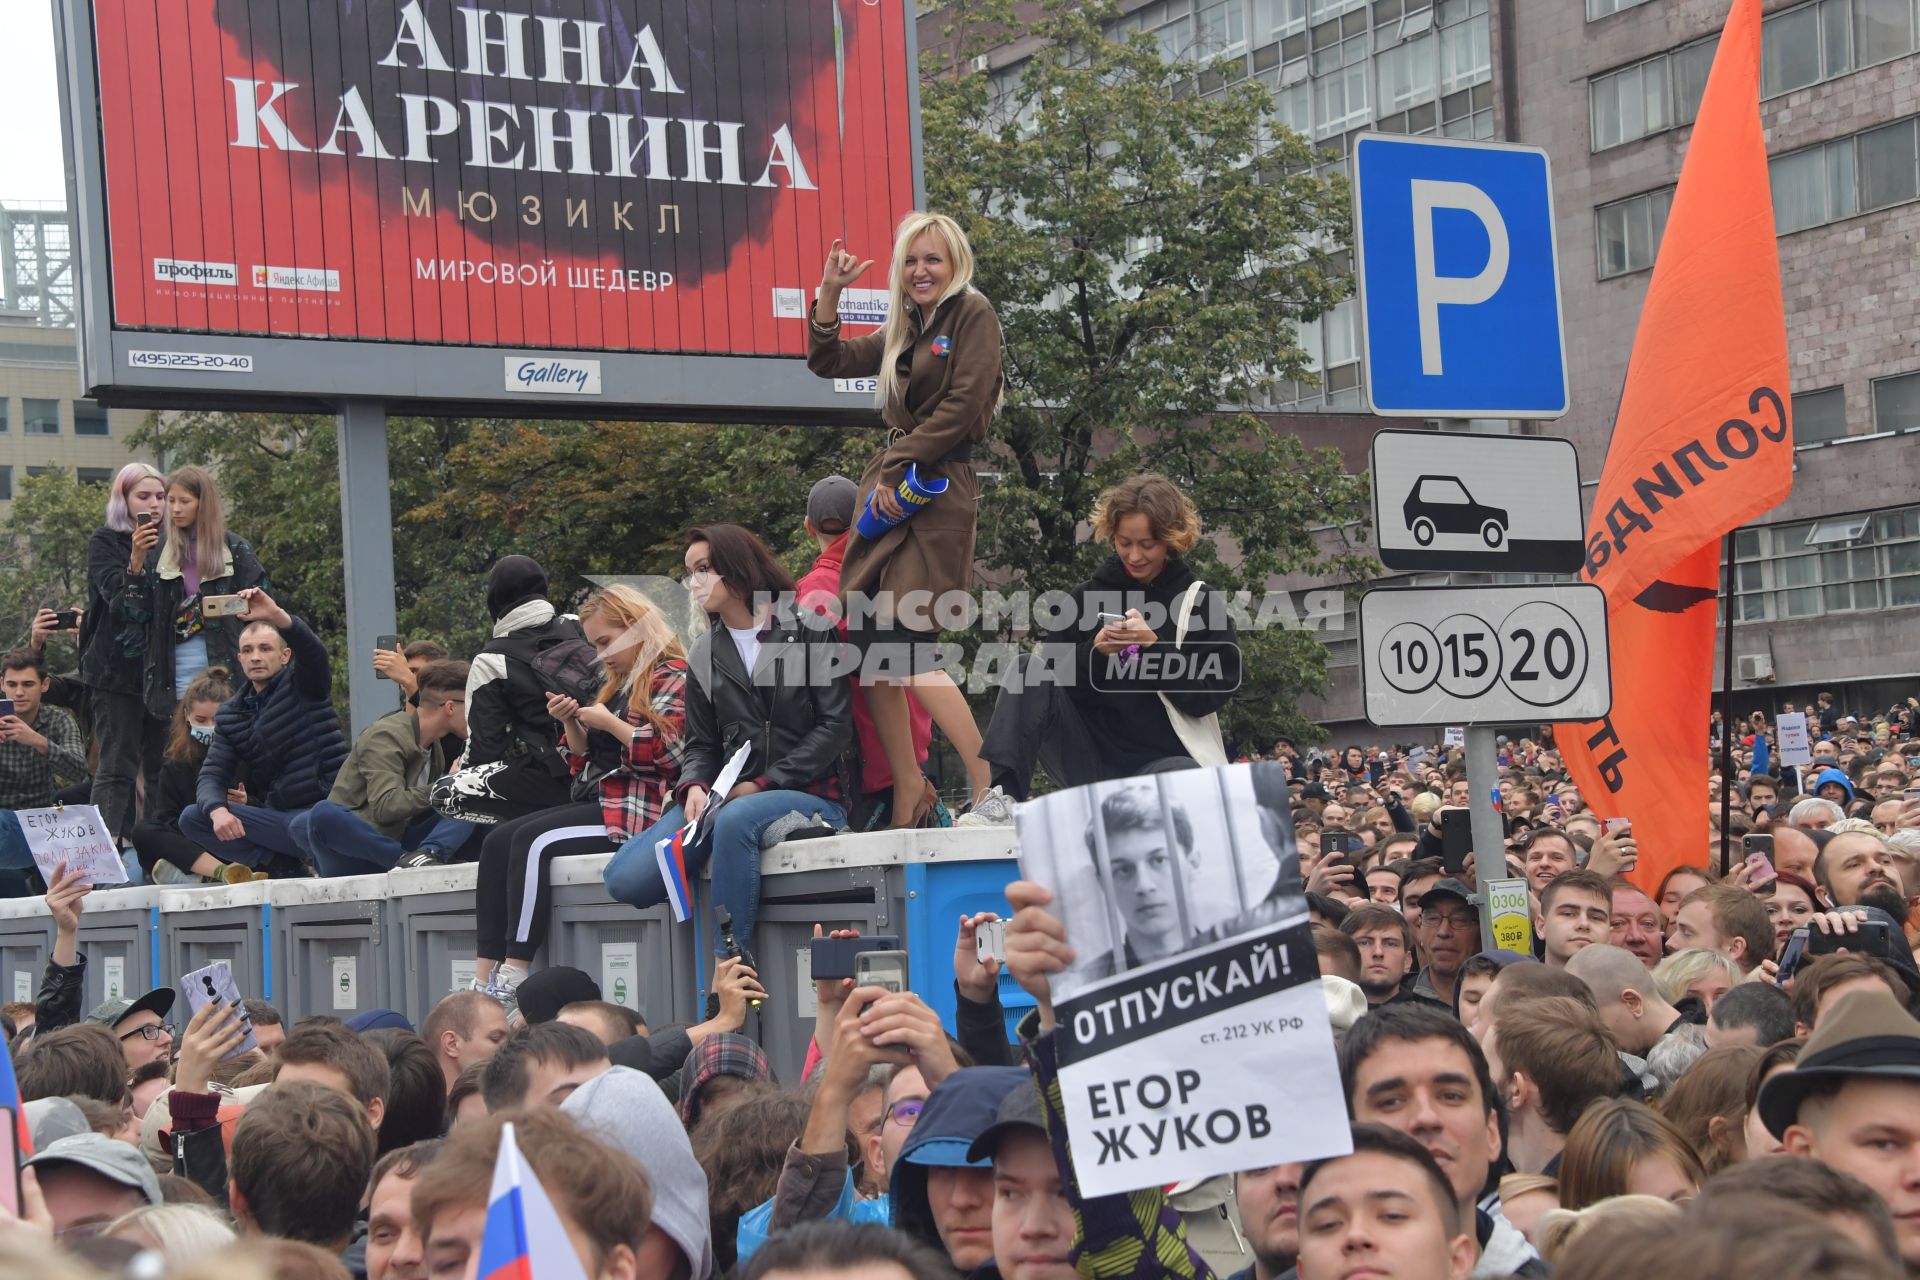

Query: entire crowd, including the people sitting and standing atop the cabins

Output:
[0, 215, 1920, 1280]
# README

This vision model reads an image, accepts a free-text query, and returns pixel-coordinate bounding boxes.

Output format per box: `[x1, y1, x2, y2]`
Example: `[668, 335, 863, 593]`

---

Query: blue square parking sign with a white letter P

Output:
[1354, 134, 1567, 418]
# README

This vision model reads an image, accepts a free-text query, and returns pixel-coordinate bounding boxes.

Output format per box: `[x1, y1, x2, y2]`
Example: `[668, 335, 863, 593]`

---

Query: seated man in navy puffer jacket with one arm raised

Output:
[180, 587, 348, 869]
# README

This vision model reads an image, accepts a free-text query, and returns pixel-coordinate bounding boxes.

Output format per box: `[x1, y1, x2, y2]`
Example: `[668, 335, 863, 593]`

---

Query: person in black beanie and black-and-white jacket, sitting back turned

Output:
[432, 557, 597, 823]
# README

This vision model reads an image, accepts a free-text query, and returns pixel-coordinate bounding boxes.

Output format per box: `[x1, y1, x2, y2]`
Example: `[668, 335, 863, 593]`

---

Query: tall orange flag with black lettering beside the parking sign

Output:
[1555, 0, 1793, 892]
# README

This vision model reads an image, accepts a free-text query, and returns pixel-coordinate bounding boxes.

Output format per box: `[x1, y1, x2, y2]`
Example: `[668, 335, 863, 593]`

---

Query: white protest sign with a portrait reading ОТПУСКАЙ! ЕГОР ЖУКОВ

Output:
[1016, 764, 1350, 1196]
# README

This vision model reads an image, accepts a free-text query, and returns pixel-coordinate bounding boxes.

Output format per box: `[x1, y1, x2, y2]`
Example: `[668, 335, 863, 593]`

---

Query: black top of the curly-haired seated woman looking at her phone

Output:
[1048, 555, 1240, 773]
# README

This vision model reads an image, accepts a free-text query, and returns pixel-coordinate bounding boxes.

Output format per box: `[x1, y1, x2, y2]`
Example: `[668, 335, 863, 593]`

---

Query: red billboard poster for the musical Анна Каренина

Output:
[92, 0, 916, 355]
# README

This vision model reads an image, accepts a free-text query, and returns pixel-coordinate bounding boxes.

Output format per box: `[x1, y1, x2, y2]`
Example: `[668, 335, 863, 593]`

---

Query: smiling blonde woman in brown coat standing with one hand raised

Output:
[806, 213, 1012, 827]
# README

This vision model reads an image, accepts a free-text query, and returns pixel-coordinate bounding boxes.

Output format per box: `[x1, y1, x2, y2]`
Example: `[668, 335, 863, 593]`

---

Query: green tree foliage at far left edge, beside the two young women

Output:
[0, 470, 106, 672]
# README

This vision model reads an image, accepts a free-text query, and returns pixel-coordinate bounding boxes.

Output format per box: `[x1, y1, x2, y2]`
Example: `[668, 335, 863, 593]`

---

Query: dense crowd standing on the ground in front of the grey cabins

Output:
[0, 702, 1920, 1280]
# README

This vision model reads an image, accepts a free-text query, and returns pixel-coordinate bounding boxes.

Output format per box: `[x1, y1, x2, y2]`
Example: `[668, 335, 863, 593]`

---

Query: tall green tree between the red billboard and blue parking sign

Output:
[922, 0, 1371, 737]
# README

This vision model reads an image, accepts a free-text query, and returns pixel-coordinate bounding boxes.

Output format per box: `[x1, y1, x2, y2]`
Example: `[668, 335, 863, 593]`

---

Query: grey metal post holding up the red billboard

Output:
[336, 399, 396, 737]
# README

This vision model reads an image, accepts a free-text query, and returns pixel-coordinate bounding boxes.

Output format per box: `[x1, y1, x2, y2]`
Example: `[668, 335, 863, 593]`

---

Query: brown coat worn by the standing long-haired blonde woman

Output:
[806, 288, 1004, 629]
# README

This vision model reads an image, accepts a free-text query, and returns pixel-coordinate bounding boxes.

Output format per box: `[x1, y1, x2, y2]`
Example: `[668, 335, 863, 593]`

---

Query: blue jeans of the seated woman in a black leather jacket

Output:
[605, 791, 847, 956]
